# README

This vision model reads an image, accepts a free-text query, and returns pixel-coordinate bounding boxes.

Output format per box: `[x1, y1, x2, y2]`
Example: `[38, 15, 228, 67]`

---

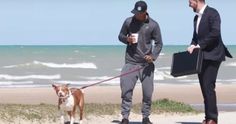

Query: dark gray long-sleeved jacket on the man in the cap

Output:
[119, 16, 163, 64]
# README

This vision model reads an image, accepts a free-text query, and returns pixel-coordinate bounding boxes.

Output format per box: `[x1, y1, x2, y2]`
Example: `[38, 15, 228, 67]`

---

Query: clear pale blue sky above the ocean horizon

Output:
[0, 0, 236, 45]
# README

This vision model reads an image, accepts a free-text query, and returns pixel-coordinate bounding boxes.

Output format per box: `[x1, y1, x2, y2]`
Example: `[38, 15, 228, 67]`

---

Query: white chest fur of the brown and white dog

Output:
[60, 95, 75, 111]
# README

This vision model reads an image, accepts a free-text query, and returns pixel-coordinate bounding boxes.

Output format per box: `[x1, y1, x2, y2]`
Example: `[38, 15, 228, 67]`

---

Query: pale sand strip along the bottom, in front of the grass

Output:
[0, 112, 236, 124]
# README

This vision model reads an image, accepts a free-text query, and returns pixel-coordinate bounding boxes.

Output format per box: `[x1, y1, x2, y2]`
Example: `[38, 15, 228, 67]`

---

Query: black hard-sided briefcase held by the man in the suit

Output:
[171, 49, 203, 77]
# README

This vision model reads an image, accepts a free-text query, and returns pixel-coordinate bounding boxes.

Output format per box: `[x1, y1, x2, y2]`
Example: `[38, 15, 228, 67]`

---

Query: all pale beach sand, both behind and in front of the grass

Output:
[0, 84, 236, 124]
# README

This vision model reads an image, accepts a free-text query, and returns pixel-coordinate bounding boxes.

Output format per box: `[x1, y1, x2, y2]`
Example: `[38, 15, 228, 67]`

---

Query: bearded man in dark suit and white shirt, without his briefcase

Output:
[187, 0, 232, 124]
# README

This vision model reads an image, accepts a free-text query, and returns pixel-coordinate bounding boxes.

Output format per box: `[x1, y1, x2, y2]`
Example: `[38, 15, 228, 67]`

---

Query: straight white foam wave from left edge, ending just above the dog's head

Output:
[0, 74, 61, 80]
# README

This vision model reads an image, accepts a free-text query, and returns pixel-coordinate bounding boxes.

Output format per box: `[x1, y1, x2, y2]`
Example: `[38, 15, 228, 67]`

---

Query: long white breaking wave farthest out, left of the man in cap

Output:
[3, 61, 97, 69]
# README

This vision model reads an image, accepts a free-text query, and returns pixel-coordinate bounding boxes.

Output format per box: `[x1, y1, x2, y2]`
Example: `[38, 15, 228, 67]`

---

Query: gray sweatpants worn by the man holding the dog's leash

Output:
[120, 63, 154, 119]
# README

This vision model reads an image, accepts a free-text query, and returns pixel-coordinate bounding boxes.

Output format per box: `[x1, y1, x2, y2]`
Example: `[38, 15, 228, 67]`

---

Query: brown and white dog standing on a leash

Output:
[52, 84, 84, 124]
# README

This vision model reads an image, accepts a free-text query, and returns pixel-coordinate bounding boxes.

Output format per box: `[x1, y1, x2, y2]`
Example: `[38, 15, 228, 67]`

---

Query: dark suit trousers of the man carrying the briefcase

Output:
[198, 60, 221, 122]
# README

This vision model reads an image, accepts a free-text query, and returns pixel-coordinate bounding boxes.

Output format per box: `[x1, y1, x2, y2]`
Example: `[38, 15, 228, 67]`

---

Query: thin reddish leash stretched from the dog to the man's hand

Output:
[80, 64, 148, 89]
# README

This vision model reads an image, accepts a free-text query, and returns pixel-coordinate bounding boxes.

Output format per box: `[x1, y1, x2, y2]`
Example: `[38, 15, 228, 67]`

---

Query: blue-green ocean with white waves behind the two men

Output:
[0, 45, 236, 87]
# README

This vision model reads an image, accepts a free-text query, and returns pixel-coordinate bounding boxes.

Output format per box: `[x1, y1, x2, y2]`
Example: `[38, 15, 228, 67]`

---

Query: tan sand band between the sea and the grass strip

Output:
[0, 84, 236, 104]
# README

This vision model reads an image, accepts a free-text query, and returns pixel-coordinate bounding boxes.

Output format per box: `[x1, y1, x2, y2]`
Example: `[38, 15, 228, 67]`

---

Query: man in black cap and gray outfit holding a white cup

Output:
[119, 1, 162, 124]
